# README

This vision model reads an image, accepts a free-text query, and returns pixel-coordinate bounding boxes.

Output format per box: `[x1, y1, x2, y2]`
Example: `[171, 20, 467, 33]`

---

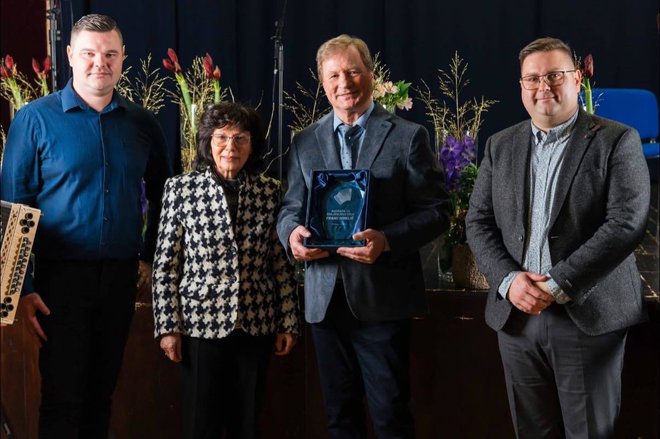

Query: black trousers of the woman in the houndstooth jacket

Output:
[181, 330, 275, 439]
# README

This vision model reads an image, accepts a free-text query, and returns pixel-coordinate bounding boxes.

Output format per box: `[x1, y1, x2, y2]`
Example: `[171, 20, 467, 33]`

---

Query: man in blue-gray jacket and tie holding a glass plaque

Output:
[278, 35, 449, 438]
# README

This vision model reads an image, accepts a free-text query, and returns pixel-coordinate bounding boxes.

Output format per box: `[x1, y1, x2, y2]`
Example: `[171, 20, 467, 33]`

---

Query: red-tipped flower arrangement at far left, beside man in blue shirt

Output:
[0, 55, 52, 117]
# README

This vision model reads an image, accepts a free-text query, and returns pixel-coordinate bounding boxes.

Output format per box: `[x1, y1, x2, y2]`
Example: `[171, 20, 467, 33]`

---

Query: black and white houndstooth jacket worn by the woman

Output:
[153, 171, 299, 339]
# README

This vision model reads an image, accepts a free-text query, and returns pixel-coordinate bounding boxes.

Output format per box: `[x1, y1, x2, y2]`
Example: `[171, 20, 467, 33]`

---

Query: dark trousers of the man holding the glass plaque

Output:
[311, 286, 415, 439]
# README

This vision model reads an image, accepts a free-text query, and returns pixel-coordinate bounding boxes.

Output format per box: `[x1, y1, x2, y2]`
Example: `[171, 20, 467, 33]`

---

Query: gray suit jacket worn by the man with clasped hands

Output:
[467, 110, 650, 335]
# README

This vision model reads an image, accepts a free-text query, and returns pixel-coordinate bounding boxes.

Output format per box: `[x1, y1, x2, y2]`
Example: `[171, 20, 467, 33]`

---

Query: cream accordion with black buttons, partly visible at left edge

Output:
[0, 201, 41, 325]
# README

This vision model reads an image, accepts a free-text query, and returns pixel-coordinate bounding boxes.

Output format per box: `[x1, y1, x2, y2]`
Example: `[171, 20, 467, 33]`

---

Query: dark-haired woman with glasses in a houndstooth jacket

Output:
[153, 103, 299, 438]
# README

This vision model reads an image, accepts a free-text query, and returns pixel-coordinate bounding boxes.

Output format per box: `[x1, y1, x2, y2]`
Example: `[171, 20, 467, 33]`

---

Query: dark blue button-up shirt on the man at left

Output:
[1, 81, 172, 282]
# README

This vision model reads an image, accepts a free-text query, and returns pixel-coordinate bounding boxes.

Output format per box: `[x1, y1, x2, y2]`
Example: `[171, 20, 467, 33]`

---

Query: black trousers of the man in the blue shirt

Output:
[35, 259, 138, 439]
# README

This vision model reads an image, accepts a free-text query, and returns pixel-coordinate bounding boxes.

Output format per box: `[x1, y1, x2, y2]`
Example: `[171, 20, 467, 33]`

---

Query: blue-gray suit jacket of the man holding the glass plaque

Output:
[277, 104, 449, 323]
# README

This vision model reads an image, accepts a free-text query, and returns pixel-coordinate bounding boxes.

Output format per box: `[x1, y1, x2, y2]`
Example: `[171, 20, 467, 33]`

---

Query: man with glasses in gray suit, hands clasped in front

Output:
[467, 38, 650, 438]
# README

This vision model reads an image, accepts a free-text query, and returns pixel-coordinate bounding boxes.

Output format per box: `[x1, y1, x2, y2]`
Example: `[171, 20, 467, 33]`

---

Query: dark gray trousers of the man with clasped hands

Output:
[498, 304, 627, 439]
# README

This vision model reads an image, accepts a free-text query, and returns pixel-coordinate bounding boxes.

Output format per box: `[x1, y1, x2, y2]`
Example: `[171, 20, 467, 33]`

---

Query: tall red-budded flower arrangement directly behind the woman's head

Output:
[163, 49, 225, 172]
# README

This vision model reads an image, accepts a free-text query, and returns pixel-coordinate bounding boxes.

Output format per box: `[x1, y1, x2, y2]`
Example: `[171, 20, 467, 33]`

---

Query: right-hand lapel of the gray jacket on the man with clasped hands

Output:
[549, 110, 600, 226]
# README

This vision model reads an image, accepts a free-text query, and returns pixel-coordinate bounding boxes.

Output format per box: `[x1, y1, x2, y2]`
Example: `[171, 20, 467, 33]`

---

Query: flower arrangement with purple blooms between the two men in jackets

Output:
[418, 52, 497, 246]
